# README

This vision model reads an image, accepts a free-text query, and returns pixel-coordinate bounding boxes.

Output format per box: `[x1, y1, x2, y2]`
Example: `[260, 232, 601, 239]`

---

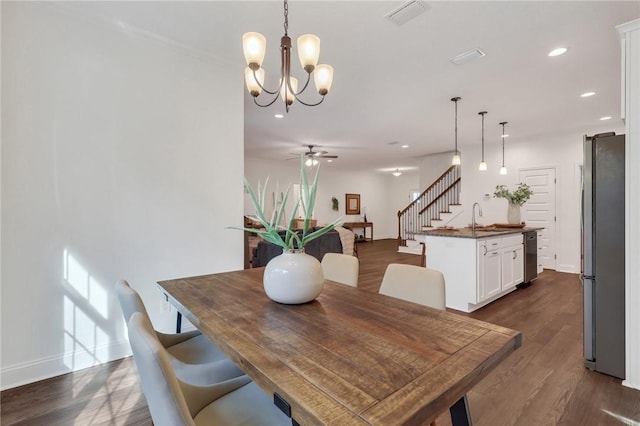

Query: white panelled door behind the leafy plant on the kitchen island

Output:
[520, 167, 556, 270]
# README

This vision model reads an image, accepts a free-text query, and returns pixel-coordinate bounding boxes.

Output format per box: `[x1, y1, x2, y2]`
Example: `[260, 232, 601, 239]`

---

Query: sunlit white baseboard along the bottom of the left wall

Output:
[0, 340, 131, 390]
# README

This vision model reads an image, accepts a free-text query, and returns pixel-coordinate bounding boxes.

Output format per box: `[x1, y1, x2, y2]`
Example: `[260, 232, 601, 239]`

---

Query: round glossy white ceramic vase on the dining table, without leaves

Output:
[262, 249, 324, 305]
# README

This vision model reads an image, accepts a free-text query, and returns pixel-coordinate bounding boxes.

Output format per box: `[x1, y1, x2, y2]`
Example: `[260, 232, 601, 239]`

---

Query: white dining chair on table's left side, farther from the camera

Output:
[115, 280, 244, 384]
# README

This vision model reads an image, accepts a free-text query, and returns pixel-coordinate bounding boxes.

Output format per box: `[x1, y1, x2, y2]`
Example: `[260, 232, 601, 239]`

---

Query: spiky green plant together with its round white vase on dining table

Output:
[234, 157, 341, 304]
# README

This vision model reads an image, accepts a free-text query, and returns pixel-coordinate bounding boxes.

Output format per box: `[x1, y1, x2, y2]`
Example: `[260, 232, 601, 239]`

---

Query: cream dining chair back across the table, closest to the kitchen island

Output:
[379, 263, 446, 310]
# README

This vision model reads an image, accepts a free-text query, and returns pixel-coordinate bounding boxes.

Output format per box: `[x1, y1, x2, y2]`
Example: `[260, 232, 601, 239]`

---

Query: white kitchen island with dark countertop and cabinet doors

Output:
[416, 226, 543, 312]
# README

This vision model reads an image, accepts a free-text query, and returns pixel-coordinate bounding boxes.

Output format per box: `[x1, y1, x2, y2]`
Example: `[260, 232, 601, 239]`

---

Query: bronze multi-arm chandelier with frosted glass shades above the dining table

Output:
[242, 0, 333, 112]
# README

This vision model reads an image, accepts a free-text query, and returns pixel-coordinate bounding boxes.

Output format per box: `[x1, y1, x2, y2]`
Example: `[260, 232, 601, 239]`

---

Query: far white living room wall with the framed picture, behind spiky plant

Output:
[245, 158, 418, 239]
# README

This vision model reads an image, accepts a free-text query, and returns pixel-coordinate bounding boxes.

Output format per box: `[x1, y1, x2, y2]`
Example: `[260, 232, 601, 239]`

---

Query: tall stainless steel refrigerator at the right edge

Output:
[581, 133, 625, 379]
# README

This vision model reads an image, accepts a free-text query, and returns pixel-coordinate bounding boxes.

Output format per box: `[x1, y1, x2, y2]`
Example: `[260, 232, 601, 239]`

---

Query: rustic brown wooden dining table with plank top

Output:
[158, 268, 522, 426]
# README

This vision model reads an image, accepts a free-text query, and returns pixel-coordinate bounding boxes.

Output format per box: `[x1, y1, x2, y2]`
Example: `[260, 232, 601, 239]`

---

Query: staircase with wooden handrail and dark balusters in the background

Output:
[398, 166, 462, 254]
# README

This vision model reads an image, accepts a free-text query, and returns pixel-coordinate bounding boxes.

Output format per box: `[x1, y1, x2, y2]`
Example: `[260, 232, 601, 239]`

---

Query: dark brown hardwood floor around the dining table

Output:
[0, 240, 640, 426]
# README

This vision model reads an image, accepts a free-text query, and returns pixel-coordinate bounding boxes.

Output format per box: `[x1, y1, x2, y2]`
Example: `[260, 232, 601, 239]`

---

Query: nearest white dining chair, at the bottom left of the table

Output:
[128, 312, 291, 426]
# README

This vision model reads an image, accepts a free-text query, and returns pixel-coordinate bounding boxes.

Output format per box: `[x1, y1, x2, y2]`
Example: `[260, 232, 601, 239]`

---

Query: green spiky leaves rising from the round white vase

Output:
[233, 156, 341, 250]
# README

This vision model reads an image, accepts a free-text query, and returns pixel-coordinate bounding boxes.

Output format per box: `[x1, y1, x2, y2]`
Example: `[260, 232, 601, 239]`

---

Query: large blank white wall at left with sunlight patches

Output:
[1, 2, 243, 388]
